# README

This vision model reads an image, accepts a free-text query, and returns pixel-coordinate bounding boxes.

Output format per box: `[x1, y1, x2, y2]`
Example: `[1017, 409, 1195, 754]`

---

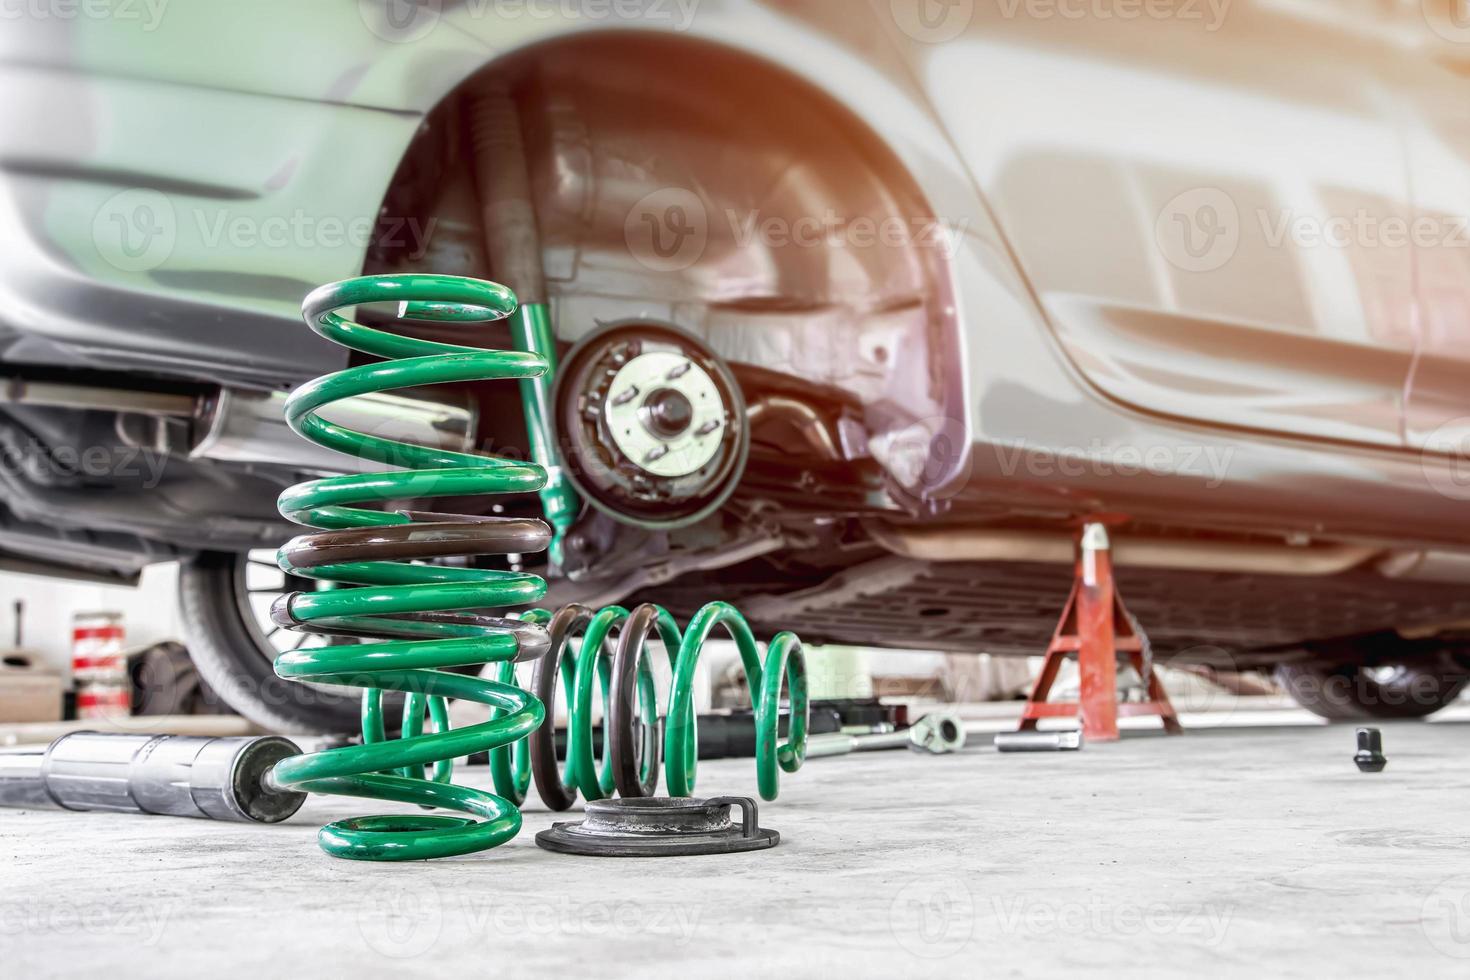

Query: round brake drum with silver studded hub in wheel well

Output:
[556, 323, 750, 527]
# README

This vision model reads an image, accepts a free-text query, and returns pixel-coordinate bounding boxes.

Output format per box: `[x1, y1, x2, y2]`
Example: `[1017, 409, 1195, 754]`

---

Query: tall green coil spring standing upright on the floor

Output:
[272, 275, 551, 861]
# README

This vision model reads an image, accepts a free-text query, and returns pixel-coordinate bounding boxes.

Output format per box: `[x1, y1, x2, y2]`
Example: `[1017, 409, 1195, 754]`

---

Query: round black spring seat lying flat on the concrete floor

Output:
[537, 796, 781, 858]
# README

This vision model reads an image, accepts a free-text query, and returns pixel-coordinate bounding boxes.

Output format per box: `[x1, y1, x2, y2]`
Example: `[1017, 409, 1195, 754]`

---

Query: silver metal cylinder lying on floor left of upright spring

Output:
[0, 732, 306, 823]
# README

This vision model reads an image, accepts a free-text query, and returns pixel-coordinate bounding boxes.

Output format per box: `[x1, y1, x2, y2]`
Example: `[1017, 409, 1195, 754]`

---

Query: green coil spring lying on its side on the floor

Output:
[523, 602, 809, 810]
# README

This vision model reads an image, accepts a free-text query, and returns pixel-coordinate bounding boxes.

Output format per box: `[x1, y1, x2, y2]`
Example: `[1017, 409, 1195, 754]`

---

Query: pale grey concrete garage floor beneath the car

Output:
[0, 713, 1470, 979]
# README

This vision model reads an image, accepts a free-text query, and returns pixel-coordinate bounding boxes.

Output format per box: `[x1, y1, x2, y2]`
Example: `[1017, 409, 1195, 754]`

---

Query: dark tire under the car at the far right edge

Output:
[1276, 663, 1470, 721]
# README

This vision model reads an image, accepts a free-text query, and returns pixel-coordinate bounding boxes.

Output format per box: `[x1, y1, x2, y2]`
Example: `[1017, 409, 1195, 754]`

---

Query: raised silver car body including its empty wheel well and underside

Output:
[0, 0, 1470, 719]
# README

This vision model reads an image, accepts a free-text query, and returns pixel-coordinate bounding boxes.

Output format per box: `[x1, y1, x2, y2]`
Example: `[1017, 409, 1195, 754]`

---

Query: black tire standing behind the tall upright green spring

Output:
[179, 551, 362, 735]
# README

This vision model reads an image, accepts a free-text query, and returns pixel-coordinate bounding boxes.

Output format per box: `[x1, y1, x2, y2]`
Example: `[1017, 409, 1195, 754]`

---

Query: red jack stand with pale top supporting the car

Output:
[1020, 523, 1183, 742]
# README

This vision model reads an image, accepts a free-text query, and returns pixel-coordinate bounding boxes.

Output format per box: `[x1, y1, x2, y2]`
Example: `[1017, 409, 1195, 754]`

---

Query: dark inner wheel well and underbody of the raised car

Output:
[0, 38, 1470, 696]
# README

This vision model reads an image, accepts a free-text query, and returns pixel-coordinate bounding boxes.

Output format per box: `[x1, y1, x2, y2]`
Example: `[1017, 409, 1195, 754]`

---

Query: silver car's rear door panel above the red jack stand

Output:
[887, 0, 1416, 447]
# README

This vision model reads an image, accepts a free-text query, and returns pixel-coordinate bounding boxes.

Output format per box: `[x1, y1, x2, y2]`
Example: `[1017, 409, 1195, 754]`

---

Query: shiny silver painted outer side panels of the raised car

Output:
[0, 0, 1470, 547]
